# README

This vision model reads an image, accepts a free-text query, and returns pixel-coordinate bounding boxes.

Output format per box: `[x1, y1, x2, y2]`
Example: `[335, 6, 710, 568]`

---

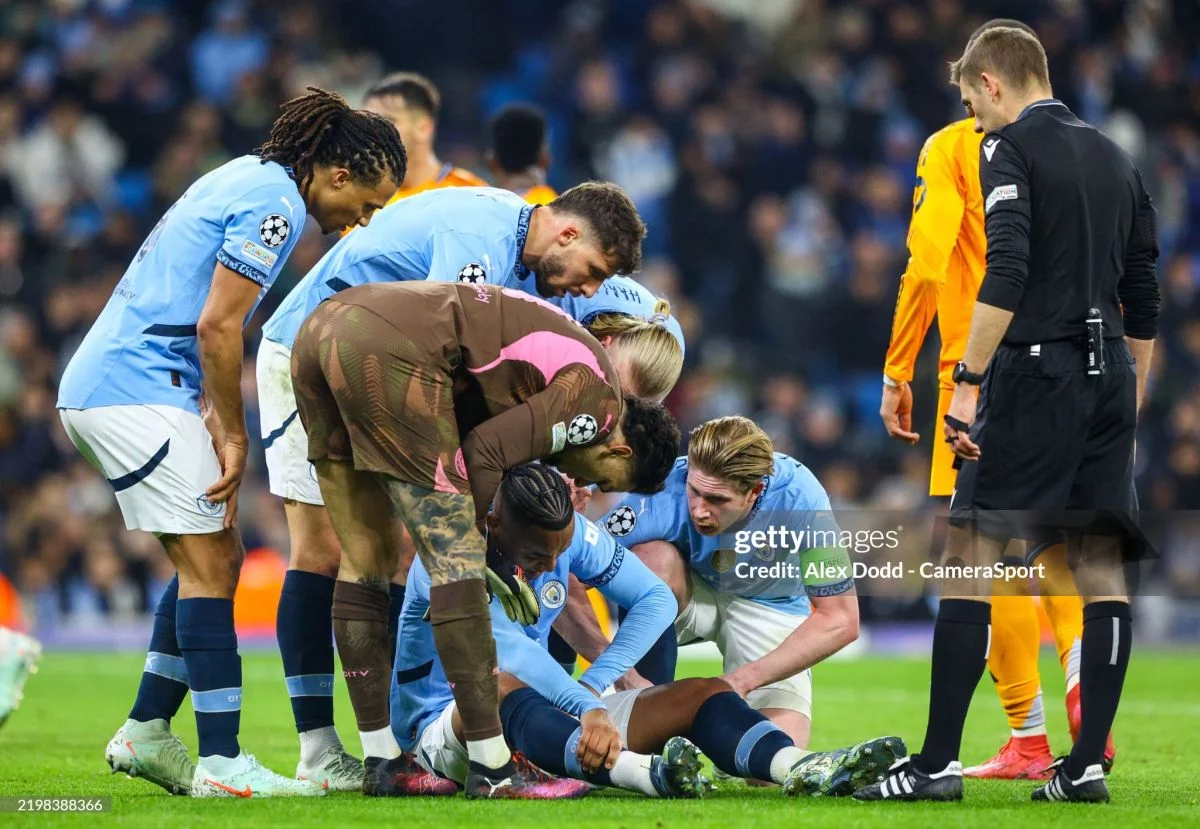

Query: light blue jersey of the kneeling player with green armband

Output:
[601, 452, 853, 615]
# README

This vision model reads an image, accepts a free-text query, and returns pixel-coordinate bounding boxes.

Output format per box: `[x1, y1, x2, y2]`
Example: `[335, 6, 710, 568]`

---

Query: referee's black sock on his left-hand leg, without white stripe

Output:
[913, 599, 991, 774]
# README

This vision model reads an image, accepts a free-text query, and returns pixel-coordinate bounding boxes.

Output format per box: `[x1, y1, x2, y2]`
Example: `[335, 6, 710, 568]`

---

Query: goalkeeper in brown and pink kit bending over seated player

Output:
[292, 282, 679, 797]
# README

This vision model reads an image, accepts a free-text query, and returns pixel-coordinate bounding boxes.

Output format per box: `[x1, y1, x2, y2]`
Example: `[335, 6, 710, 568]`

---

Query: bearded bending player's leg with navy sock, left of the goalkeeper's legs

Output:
[276, 498, 364, 792]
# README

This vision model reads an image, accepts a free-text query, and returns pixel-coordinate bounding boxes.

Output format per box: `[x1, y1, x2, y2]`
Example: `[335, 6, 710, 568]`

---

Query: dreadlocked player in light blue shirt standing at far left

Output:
[58, 89, 407, 797]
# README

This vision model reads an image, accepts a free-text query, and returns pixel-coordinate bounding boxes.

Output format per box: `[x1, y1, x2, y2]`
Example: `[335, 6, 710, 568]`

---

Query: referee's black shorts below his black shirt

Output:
[950, 340, 1138, 543]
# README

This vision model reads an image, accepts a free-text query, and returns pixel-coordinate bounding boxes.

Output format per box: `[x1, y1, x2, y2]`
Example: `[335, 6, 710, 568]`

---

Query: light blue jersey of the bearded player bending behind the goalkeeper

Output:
[263, 187, 534, 348]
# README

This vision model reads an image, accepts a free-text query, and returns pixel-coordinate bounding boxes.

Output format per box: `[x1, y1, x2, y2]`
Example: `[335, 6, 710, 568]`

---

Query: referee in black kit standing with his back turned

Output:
[856, 28, 1158, 801]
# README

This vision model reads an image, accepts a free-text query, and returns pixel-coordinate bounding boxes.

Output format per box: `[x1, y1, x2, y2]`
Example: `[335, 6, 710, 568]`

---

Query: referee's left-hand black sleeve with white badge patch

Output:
[979, 134, 1030, 311]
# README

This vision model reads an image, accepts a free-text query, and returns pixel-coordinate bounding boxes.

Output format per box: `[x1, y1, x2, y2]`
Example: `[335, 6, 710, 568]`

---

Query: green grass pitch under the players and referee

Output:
[0, 651, 1200, 829]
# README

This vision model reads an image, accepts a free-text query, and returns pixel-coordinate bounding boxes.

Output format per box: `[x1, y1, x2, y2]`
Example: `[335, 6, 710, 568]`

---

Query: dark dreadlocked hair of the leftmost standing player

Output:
[254, 86, 408, 193]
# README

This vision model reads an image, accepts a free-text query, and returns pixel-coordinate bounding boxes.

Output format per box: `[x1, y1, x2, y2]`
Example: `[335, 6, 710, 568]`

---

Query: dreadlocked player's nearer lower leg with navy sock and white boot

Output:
[154, 530, 325, 798]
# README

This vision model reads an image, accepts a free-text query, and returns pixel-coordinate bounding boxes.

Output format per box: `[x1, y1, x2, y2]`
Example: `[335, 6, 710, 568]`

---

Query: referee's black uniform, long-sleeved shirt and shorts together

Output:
[950, 100, 1159, 537]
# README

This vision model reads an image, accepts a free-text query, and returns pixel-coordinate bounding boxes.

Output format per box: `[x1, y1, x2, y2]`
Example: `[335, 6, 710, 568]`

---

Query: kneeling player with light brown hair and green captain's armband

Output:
[595, 416, 858, 747]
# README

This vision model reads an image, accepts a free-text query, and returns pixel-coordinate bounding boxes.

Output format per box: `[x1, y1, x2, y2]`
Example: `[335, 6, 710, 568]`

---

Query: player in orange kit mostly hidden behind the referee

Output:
[880, 19, 1116, 780]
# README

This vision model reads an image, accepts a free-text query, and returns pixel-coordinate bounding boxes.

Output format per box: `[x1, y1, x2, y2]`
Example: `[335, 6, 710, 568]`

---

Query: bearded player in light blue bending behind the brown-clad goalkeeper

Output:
[257, 182, 652, 793]
